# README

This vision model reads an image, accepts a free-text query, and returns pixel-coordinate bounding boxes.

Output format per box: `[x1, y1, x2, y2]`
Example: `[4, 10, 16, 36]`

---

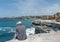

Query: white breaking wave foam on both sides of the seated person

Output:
[0, 27, 35, 36]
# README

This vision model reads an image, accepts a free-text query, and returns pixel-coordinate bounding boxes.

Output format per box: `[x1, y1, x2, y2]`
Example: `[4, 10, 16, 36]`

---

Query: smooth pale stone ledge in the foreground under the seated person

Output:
[7, 31, 60, 42]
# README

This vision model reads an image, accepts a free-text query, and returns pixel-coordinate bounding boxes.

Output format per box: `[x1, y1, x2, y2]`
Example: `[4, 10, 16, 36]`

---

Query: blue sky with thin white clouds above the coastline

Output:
[0, 0, 60, 17]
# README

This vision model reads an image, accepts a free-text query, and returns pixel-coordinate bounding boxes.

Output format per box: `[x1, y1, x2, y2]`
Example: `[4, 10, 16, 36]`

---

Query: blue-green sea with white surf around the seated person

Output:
[0, 19, 35, 42]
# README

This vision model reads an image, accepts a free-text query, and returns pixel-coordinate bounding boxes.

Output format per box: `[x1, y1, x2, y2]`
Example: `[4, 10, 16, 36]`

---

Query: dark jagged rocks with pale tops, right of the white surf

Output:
[32, 19, 60, 33]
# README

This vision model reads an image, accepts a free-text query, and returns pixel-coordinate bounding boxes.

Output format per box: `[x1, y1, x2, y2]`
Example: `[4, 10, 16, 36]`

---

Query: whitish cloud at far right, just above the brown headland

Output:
[42, 4, 60, 15]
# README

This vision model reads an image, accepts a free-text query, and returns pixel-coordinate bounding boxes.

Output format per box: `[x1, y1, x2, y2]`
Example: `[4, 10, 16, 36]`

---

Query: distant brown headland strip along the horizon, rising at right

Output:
[0, 12, 60, 22]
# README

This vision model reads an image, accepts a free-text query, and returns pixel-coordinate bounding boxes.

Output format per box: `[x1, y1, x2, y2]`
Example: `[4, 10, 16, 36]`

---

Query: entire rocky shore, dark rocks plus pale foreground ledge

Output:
[7, 20, 60, 42]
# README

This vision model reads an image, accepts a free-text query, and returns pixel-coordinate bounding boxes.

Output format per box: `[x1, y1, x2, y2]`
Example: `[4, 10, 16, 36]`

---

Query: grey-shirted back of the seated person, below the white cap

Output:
[16, 21, 27, 40]
